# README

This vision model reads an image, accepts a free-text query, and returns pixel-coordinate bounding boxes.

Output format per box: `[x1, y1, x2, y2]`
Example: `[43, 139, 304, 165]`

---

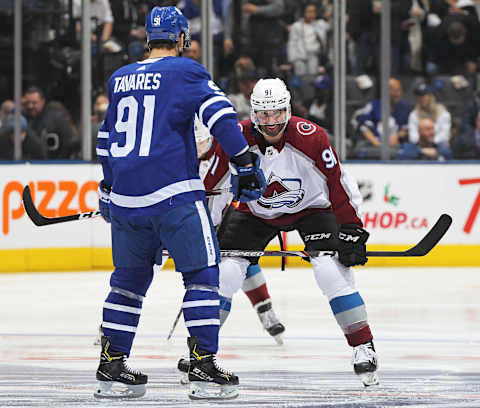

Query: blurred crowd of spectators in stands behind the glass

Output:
[0, 0, 480, 160]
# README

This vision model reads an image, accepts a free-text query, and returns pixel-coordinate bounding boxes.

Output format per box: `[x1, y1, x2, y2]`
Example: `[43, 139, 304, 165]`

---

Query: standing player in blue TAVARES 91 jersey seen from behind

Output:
[95, 7, 265, 399]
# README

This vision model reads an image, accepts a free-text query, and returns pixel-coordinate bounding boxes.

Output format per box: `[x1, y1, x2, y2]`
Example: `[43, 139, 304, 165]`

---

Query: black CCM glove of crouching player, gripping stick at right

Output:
[338, 224, 370, 266]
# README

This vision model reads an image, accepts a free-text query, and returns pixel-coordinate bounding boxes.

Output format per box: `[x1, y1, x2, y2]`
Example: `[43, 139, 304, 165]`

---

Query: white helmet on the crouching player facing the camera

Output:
[250, 78, 291, 133]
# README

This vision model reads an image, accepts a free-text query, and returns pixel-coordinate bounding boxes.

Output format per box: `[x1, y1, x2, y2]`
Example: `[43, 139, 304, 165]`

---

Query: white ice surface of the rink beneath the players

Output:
[0, 267, 480, 408]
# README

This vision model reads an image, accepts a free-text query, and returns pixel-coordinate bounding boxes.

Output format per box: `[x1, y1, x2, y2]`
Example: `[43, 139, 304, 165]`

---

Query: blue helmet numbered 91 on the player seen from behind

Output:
[145, 6, 190, 48]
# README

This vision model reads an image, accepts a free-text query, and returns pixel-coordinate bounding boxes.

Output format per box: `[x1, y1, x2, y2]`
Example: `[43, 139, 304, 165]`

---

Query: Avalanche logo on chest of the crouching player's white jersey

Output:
[257, 173, 305, 209]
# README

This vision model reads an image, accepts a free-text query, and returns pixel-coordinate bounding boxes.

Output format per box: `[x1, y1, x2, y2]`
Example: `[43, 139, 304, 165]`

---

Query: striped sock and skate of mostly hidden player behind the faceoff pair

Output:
[242, 260, 285, 345]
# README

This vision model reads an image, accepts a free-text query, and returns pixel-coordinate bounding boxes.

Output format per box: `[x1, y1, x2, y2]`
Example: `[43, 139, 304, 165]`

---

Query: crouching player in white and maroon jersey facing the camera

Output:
[204, 78, 379, 386]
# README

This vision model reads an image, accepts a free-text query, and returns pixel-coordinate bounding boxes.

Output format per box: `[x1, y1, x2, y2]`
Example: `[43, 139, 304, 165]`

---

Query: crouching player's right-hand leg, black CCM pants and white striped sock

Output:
[298, 213, 379, 386]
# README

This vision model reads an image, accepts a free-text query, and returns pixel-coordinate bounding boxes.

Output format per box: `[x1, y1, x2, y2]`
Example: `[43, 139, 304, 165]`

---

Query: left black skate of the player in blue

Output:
[94, 336, 148, 398]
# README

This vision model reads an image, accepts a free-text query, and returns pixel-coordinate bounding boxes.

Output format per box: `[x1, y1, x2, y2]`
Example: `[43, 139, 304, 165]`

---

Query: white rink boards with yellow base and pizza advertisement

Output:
[0, 163, 480, 272]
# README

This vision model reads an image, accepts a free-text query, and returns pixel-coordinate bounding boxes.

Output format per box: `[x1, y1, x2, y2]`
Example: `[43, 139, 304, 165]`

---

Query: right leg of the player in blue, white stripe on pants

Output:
[160, 201, 238, 399]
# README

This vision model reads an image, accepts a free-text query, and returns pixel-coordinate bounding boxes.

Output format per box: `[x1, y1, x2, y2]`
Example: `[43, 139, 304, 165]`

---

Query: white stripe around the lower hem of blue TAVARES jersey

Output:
[110, 179, 205, 208]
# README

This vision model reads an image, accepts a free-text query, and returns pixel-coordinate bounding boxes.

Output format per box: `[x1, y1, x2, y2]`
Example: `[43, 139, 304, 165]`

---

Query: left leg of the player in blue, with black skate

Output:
[94, 215, 155, 398]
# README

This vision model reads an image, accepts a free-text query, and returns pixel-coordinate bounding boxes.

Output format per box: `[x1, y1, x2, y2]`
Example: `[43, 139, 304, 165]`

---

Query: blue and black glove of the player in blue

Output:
[230, 151, 267, 203]
